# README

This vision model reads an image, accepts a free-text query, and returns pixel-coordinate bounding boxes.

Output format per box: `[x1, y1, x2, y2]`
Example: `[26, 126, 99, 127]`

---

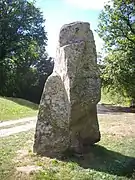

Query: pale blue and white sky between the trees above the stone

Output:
[36, 0, 107, 58]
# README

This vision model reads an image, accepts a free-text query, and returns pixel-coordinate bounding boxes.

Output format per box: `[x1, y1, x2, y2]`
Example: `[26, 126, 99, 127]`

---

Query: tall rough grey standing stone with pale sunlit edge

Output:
[34, 22, 100, 156]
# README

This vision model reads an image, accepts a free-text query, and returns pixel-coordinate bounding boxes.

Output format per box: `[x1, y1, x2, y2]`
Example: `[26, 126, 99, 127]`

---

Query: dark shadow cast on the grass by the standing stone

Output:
[63, 145, 135, 177]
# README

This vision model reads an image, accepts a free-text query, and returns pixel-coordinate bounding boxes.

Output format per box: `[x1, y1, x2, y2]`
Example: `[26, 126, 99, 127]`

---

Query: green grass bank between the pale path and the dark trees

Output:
[0, 97, 38, 121]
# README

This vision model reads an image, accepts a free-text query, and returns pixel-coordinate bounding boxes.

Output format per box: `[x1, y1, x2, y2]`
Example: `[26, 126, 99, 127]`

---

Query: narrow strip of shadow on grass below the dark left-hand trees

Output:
[4, 97, 38, 110]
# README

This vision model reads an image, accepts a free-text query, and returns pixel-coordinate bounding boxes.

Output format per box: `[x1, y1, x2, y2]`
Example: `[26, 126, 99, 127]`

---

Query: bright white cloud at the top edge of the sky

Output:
[65, 0, 108, 10]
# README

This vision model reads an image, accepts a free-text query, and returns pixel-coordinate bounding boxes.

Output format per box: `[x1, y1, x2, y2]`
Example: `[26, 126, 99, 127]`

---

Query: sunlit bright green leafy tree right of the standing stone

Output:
[97, 0, 135, 99]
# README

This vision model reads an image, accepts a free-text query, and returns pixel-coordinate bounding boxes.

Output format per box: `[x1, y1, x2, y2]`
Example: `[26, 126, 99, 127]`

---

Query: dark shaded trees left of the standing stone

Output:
[0, 0, 53, 103]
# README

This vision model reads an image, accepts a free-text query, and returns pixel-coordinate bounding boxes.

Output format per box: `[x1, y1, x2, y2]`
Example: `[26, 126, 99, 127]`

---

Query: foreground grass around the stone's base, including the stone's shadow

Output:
[0, 113, 135, 180]
